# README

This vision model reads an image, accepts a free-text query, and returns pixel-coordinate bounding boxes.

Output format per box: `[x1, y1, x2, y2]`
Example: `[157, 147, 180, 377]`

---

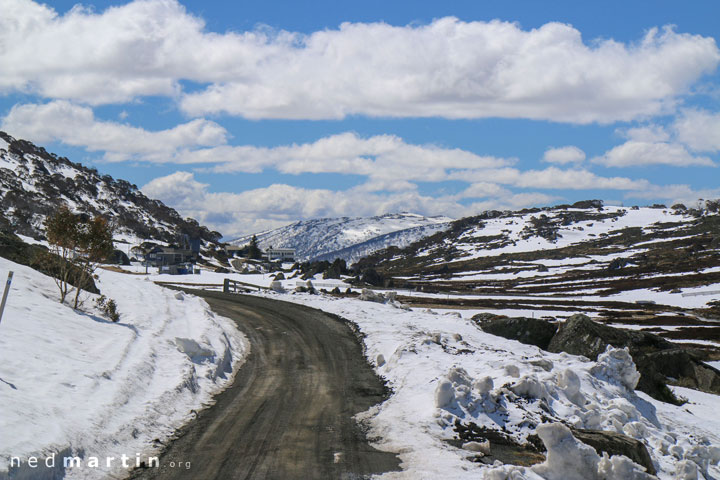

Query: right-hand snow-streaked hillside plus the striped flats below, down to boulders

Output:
[350, 201, 720, 358]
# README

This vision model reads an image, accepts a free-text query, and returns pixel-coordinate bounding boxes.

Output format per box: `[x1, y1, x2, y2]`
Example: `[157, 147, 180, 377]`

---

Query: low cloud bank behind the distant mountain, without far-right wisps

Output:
[142, 171, 557, 238]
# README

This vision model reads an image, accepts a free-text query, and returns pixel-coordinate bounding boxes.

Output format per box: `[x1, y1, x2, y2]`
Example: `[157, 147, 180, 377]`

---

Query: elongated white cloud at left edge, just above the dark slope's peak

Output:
[0, 100, 227, 162]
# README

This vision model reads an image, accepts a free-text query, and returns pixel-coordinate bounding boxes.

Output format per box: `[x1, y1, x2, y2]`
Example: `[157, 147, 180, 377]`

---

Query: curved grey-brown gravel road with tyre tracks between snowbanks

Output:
[133, 290, 399, 480]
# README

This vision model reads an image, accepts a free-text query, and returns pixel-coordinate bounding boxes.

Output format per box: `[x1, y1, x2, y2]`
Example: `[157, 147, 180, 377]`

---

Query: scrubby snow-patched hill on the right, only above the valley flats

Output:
[360, 202, 720, 295]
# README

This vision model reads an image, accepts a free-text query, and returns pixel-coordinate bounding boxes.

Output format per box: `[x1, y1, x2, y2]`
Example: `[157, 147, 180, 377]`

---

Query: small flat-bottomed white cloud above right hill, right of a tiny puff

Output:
[592, 140, 715, 167]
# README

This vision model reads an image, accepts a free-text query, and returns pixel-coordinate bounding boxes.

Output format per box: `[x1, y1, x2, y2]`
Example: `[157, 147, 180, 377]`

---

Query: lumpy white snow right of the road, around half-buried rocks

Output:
[263, 293, 720, 480]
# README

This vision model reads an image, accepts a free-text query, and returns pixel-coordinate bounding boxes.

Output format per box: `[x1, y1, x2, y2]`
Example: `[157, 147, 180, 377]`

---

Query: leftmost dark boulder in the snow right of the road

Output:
[472, 313, 558, 350]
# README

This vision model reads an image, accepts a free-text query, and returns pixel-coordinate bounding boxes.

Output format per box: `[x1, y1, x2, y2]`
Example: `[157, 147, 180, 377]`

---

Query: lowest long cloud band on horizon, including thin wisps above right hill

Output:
[142, 168, 667, 238]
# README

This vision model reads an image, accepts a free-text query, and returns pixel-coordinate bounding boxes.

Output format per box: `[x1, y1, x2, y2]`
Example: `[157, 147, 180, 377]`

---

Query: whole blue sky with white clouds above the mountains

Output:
[0, 0, 720, 237]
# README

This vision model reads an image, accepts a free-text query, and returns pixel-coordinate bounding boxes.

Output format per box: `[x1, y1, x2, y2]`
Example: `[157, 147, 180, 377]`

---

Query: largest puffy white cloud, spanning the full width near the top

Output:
[0, 0, 720, 123]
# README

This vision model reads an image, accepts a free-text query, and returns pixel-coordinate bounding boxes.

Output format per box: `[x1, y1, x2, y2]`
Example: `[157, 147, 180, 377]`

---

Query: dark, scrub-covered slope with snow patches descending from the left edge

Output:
[0, 132, 221, 251]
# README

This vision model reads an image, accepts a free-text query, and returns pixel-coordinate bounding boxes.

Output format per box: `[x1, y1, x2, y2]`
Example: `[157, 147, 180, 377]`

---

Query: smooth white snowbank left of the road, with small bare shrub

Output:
[0, 258, 248, 479]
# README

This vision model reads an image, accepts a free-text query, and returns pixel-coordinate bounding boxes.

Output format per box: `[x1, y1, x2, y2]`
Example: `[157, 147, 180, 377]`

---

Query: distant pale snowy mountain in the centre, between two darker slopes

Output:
[230, 213, 452, 262]
